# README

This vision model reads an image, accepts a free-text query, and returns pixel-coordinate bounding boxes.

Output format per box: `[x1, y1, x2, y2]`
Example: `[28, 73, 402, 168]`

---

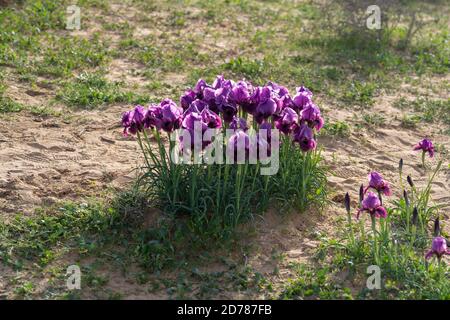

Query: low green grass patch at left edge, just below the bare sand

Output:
[0, 203, 117, 268]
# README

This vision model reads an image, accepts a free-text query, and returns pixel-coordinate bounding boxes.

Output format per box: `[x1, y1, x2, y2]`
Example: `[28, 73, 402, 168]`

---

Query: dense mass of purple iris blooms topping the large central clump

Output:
[122, 76, 324, 152]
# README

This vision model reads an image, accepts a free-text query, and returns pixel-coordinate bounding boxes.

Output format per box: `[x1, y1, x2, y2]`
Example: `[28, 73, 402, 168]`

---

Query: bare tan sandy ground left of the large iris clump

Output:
[0, 106, 140, 214]
